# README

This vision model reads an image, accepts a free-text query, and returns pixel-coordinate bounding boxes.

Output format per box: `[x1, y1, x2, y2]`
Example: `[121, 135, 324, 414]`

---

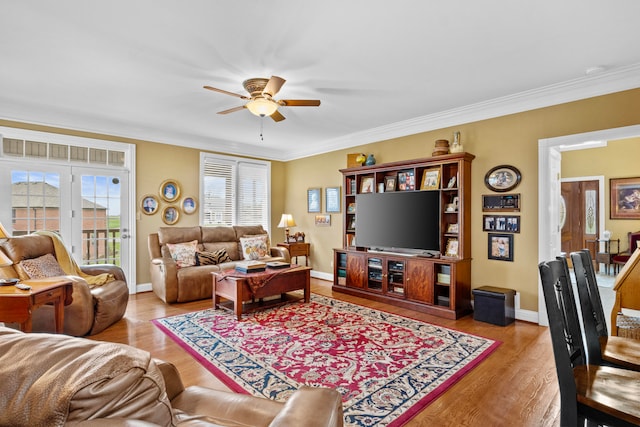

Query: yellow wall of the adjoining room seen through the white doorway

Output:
[562, 138, 640, 250]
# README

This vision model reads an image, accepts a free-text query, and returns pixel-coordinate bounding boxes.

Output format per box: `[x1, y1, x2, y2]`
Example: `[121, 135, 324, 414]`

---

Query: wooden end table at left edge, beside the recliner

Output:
[0, 277, 73, 333]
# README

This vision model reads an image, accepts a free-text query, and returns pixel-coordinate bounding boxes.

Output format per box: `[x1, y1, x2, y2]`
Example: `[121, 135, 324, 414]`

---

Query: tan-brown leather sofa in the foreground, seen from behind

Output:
[0, 327, 343, 427]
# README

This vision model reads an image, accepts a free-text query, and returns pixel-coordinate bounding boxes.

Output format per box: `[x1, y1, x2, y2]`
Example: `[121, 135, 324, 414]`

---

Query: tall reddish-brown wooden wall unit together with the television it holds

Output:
[333, 153, 475, 319]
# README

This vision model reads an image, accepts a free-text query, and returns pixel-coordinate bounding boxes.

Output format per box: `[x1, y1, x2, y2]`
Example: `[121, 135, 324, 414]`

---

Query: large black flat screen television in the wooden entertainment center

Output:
[356, 191, 440, 256]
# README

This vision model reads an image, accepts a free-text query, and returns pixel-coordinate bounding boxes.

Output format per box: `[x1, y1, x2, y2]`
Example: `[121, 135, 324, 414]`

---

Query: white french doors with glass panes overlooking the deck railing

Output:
[0, 161, 135, 290]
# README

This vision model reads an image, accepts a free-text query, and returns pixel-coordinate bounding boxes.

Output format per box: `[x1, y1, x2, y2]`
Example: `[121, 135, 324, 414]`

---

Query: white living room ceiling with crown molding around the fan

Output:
[0, 0, 640, 160]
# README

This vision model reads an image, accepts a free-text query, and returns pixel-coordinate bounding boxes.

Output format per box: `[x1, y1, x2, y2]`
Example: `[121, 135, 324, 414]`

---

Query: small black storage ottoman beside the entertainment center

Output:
[473, 286, 516, 326]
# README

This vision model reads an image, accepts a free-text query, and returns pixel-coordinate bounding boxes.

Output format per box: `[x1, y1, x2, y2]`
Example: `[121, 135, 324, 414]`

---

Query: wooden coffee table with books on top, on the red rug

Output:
[211, 266, 311, 320]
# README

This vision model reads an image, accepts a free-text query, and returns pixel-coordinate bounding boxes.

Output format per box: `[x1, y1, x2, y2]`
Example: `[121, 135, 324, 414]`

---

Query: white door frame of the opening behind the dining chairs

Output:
[538, 125, 640, 326]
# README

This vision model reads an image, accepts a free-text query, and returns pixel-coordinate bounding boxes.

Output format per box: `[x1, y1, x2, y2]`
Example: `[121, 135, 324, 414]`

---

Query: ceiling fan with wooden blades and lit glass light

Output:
[204, 76, 320, 122]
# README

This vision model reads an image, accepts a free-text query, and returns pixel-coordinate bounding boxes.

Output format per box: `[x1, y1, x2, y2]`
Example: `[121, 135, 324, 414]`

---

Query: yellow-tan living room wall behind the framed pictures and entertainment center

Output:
[0, 89, 640, 311]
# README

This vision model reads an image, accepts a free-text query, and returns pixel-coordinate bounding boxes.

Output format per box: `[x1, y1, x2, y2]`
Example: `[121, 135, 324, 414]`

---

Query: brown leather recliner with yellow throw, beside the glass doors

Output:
[0, 234, 129, 336]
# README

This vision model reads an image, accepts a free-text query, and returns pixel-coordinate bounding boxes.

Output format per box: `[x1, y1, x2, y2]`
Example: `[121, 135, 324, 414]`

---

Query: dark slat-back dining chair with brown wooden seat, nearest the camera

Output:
[538, 257, 640, 427]
